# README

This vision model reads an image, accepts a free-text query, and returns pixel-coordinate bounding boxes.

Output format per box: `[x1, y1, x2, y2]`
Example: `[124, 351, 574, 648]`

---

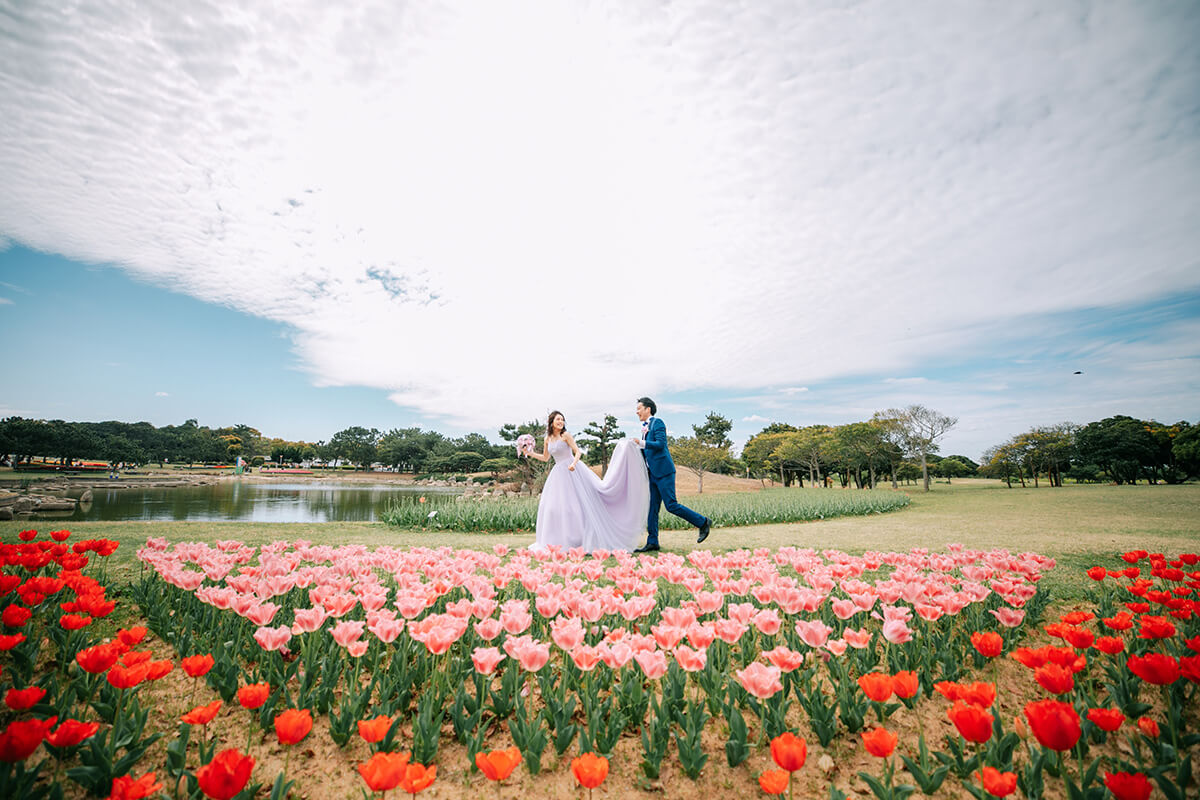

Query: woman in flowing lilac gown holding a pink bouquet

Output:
[524, 411, 650, 553]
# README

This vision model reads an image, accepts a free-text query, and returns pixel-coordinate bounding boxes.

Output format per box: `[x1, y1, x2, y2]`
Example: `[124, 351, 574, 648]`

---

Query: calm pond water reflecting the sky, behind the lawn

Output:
[56, 481, 457, 522]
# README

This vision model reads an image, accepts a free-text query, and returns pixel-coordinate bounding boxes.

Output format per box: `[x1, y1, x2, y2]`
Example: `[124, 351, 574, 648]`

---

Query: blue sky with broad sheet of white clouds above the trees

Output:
[0, 0, 1200, 458]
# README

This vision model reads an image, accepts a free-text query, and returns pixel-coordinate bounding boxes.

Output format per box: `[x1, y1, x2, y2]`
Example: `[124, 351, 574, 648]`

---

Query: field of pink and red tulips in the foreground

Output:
[0, 530, 1200, 800]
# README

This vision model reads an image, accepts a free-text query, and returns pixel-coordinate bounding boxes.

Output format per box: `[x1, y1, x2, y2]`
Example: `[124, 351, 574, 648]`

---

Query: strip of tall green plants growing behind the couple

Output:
[380, 489, 908, 531]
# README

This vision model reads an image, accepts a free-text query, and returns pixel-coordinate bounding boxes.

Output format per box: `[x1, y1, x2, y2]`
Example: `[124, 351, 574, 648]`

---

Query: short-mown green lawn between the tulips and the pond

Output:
[0, 480, 1200, 597]
